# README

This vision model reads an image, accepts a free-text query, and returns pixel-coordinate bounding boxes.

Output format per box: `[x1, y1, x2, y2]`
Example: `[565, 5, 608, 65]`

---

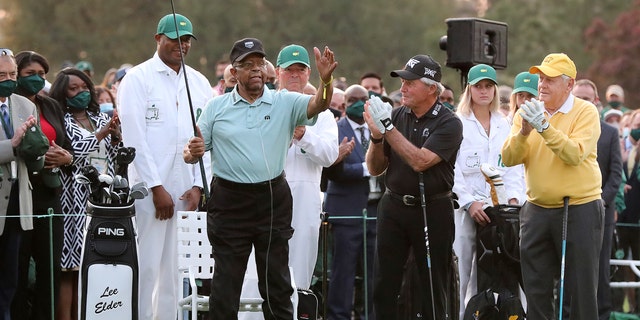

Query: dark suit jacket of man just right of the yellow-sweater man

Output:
[598, 120, 622, 224]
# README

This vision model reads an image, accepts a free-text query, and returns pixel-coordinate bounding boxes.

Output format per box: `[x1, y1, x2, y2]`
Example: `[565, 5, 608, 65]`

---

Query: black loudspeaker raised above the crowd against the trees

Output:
[441, 18, 507, 70]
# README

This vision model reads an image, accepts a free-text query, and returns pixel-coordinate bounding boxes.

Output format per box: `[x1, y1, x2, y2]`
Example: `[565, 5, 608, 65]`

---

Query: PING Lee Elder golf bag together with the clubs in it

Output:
[75, 148, 148, 320]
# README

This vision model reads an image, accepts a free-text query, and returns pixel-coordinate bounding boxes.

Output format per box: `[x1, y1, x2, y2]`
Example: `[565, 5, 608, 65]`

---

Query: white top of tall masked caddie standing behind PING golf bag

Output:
[118, 52, 213, 192]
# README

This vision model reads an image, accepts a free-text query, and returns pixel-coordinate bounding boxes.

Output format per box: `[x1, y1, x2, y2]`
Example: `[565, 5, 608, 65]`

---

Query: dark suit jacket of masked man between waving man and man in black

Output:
[325, 117, 369, 224]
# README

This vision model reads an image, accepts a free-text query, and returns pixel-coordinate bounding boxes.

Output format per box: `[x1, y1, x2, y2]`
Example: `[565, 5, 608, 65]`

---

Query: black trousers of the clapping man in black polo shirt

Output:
[373, 193, 455, 320]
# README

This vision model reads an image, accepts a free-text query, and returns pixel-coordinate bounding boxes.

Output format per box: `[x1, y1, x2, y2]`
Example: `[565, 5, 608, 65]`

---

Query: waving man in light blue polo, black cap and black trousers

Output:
[184, 38, 337, 319]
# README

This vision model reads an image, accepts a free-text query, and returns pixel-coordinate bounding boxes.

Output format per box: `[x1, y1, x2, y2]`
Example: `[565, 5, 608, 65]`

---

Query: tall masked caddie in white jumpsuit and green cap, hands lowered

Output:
[118, 14, 213, 320]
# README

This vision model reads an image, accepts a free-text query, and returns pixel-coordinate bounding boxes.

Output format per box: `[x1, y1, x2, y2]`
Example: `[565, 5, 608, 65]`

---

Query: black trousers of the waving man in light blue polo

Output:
[207, 176, 293, 320]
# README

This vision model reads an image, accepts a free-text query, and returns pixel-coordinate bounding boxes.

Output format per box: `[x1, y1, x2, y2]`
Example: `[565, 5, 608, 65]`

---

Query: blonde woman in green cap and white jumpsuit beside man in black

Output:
[453, 64, 522, 318]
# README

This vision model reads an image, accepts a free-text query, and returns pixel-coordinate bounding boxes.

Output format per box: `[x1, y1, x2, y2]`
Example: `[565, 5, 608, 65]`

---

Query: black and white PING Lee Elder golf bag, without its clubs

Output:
[78, 201, 138, 320]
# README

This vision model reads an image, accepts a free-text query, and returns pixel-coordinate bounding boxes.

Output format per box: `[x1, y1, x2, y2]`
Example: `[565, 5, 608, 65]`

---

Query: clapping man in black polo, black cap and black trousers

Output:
[365, 55, 462, 319]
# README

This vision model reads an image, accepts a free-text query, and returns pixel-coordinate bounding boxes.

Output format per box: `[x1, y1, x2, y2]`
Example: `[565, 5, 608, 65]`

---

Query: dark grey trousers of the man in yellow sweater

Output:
[520, 200, 604, 320]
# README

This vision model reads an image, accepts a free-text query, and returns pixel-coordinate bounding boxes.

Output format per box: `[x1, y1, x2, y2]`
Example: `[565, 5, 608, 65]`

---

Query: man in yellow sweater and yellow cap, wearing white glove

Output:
[502, 53, 604, 320]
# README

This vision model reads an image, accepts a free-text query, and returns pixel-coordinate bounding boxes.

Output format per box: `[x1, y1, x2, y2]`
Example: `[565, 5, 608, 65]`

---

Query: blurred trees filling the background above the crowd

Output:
[0, 0, 640, 102]
